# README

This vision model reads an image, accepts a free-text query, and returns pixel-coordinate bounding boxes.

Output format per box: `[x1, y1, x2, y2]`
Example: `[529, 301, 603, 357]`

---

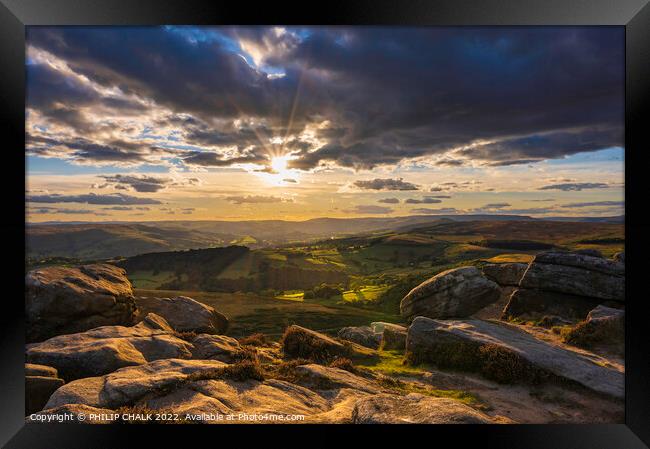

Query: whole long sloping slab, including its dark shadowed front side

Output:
[406, 317, 624, 398]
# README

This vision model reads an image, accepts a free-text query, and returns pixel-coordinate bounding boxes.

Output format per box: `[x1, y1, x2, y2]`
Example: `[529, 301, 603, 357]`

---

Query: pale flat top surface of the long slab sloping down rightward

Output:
[407, 317, 625, 398]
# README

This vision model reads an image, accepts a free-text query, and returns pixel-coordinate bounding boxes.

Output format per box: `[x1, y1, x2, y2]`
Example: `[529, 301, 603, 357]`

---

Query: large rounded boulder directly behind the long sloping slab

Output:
[400, 267, 500, 320]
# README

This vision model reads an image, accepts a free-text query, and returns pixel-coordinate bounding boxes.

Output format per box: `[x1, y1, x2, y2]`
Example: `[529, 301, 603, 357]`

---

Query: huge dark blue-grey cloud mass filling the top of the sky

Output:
[27, 27, 624, 169]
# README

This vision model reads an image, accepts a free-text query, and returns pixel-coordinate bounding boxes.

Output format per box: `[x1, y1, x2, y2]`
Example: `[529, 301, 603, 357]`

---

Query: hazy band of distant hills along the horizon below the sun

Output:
[26, 215, 622, 260]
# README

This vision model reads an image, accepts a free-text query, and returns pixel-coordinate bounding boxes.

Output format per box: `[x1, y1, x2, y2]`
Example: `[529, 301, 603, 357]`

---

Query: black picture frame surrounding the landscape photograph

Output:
[0, 0, 650, 449]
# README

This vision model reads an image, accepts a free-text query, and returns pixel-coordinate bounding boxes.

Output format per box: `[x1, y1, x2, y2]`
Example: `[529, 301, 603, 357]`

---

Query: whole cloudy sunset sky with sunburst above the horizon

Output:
[25, 26, 624, 222]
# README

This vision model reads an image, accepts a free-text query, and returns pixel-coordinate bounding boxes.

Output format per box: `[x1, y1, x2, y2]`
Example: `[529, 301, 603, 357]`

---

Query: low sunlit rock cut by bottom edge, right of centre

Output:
[352, 393, 493, 424]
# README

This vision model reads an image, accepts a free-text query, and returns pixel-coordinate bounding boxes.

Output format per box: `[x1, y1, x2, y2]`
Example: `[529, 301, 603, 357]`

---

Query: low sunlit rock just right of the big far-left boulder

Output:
[135, 296, 228, 334]
